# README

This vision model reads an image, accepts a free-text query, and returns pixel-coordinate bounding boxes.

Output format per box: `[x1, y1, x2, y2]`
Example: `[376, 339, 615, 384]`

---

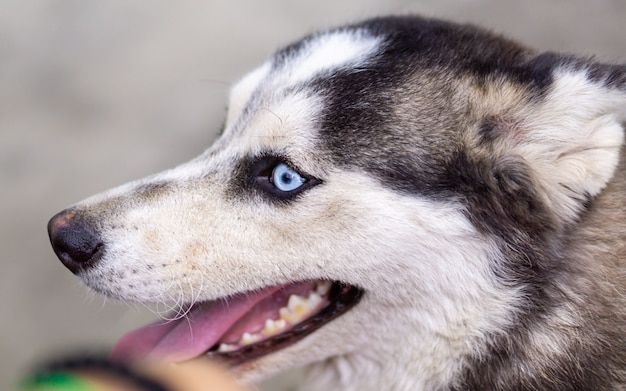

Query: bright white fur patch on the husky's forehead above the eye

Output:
[225, 28, 383, 150]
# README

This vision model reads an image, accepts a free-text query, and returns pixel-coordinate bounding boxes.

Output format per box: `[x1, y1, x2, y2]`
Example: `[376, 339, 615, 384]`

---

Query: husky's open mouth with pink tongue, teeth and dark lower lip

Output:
[113, 280, 363, 366]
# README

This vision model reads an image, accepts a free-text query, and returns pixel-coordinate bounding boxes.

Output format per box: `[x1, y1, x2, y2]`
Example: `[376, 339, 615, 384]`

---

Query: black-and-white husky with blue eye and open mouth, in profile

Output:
[49, 17, 626, 390]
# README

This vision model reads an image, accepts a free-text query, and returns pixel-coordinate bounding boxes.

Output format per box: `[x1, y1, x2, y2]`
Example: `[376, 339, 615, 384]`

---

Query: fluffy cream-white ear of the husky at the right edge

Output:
[494, 58, 626, 223]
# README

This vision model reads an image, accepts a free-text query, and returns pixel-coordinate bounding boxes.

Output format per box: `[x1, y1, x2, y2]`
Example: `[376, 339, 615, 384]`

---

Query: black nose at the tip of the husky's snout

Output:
[48, 209, 104, 274]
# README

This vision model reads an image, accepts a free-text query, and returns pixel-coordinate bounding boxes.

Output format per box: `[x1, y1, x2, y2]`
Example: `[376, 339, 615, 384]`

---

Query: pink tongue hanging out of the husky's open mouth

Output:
[112, 286, 281, 362]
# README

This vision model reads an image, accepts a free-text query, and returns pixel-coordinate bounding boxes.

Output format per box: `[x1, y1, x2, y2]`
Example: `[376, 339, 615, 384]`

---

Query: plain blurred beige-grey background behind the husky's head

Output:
[0, 0, 626, 389]
